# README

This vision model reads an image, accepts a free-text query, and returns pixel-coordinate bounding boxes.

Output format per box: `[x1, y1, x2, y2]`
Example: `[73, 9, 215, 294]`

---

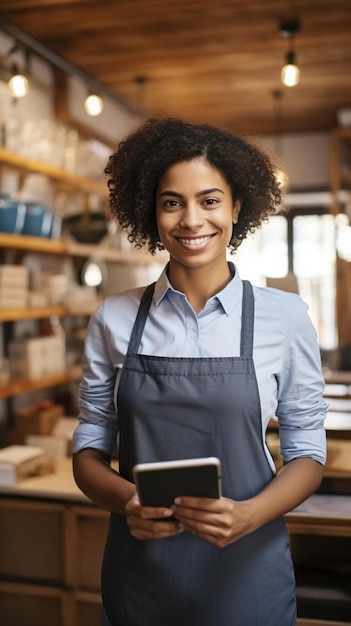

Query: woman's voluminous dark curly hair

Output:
[105, 118, 281, 254]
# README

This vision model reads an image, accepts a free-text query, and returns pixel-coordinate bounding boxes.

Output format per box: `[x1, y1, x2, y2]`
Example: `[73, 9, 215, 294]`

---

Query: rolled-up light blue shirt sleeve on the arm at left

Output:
[73, 304, 118, 454]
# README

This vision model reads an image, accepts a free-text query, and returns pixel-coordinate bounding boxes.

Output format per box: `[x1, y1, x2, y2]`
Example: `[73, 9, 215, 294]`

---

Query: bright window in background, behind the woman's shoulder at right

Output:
[234, 207, 337, 350]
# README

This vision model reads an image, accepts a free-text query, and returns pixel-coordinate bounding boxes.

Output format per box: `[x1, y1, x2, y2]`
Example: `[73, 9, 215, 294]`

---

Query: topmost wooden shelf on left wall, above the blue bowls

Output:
[0, 147, 108, 195]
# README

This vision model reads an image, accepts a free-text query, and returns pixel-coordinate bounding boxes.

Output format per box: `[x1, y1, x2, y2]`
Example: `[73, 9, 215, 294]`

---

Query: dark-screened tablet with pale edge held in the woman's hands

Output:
[133, 457, 221, 507]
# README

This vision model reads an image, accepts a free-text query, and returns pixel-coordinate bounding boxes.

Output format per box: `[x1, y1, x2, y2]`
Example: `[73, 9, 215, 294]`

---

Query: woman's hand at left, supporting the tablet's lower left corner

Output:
[125, 494, 184, 539]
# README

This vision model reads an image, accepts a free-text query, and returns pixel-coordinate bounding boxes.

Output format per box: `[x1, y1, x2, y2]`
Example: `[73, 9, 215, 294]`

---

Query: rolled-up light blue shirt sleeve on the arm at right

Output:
[277, 300, 328, 464]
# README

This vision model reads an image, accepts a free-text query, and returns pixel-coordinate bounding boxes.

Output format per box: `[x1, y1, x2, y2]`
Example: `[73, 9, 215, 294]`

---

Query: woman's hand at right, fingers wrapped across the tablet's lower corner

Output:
[172, 497, 252, 548]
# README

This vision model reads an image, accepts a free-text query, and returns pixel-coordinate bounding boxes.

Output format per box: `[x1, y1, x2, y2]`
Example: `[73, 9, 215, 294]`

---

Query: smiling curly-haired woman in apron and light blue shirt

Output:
[74, 119, 327, 626]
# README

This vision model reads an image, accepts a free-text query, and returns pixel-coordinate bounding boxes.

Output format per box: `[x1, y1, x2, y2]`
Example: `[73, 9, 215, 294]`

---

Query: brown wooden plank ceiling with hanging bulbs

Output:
[0, 0, 351, 133]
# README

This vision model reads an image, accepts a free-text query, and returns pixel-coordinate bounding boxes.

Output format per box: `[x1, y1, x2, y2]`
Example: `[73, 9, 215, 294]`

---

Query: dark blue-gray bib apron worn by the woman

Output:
[102, 281, 296, 626]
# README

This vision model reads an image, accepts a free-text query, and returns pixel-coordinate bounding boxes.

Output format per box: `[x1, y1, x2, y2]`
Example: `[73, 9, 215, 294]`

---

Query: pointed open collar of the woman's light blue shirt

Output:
[154, 261, 243, 315]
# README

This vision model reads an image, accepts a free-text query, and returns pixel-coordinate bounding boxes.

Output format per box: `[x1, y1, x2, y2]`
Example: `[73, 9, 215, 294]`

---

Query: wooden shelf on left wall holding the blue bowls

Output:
[0, 233, 168, 265]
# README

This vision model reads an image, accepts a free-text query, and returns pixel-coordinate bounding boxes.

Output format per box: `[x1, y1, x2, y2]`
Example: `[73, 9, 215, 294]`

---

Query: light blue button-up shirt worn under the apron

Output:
[73, 264, 328, 470]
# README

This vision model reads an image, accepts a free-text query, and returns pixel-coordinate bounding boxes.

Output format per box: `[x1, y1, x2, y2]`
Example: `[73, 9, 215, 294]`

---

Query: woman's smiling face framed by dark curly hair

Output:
[156, 157, 240, 271]
